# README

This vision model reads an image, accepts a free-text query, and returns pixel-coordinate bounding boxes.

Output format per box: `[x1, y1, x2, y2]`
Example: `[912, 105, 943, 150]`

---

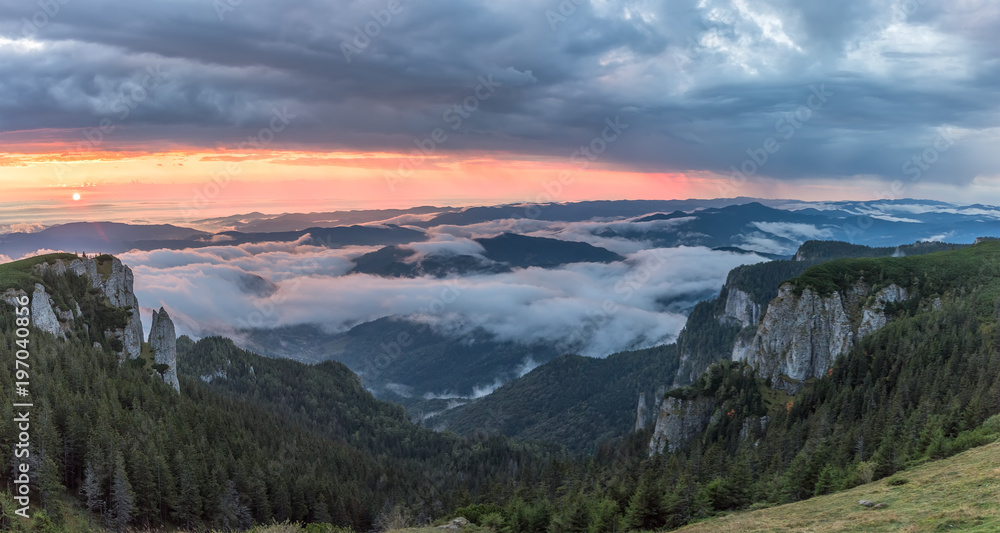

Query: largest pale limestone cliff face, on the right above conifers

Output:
[733, 283, 908, 386]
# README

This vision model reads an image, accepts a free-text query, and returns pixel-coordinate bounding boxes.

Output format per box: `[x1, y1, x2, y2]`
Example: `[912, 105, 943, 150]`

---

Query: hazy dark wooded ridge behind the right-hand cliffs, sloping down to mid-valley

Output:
[438, 241, 964, 452]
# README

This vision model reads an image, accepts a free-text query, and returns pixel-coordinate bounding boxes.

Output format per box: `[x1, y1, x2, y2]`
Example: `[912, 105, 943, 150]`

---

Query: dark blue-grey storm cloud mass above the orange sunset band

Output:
[0, 0, 1000, 183]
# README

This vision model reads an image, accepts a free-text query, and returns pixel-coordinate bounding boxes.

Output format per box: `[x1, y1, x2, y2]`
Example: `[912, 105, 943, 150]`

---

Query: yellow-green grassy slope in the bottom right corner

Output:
[678, 442, 1000, 533]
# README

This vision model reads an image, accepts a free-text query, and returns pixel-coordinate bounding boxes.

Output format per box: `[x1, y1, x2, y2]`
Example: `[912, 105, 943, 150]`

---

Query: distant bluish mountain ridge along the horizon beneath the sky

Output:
[0, 198, 1000, 260]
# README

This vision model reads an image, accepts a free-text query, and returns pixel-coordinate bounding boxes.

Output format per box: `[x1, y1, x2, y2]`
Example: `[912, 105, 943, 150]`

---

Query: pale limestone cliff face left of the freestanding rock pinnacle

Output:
[32, 258, 142, 359]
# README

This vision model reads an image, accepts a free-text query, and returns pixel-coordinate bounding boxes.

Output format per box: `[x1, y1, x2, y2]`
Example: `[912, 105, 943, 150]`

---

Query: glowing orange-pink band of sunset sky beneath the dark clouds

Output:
[0, 142, 992, 219]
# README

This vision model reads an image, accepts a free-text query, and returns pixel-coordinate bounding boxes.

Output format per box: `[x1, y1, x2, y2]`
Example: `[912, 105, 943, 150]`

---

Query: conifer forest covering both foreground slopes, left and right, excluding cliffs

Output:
[7, 241, 1000, 533]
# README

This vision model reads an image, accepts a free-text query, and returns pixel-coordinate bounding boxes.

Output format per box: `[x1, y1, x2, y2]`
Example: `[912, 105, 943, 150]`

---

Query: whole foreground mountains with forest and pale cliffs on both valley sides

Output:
[0, 227, 1000, 533]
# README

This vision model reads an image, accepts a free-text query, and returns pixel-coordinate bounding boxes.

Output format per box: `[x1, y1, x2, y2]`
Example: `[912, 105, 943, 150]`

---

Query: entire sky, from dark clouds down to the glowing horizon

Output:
[0, 0, 1000, 218]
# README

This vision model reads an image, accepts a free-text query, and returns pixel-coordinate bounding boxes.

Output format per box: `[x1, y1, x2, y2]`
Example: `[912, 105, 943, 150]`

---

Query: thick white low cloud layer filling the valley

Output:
[121, 240, 762, 357]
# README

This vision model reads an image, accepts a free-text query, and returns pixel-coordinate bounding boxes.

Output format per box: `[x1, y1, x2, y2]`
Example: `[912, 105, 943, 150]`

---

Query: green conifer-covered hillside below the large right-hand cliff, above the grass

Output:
[452, 242, 1000, 532]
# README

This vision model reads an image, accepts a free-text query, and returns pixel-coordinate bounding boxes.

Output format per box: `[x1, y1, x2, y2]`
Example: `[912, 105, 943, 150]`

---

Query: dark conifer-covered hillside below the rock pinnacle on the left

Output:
[0, 256, 551, 531]
